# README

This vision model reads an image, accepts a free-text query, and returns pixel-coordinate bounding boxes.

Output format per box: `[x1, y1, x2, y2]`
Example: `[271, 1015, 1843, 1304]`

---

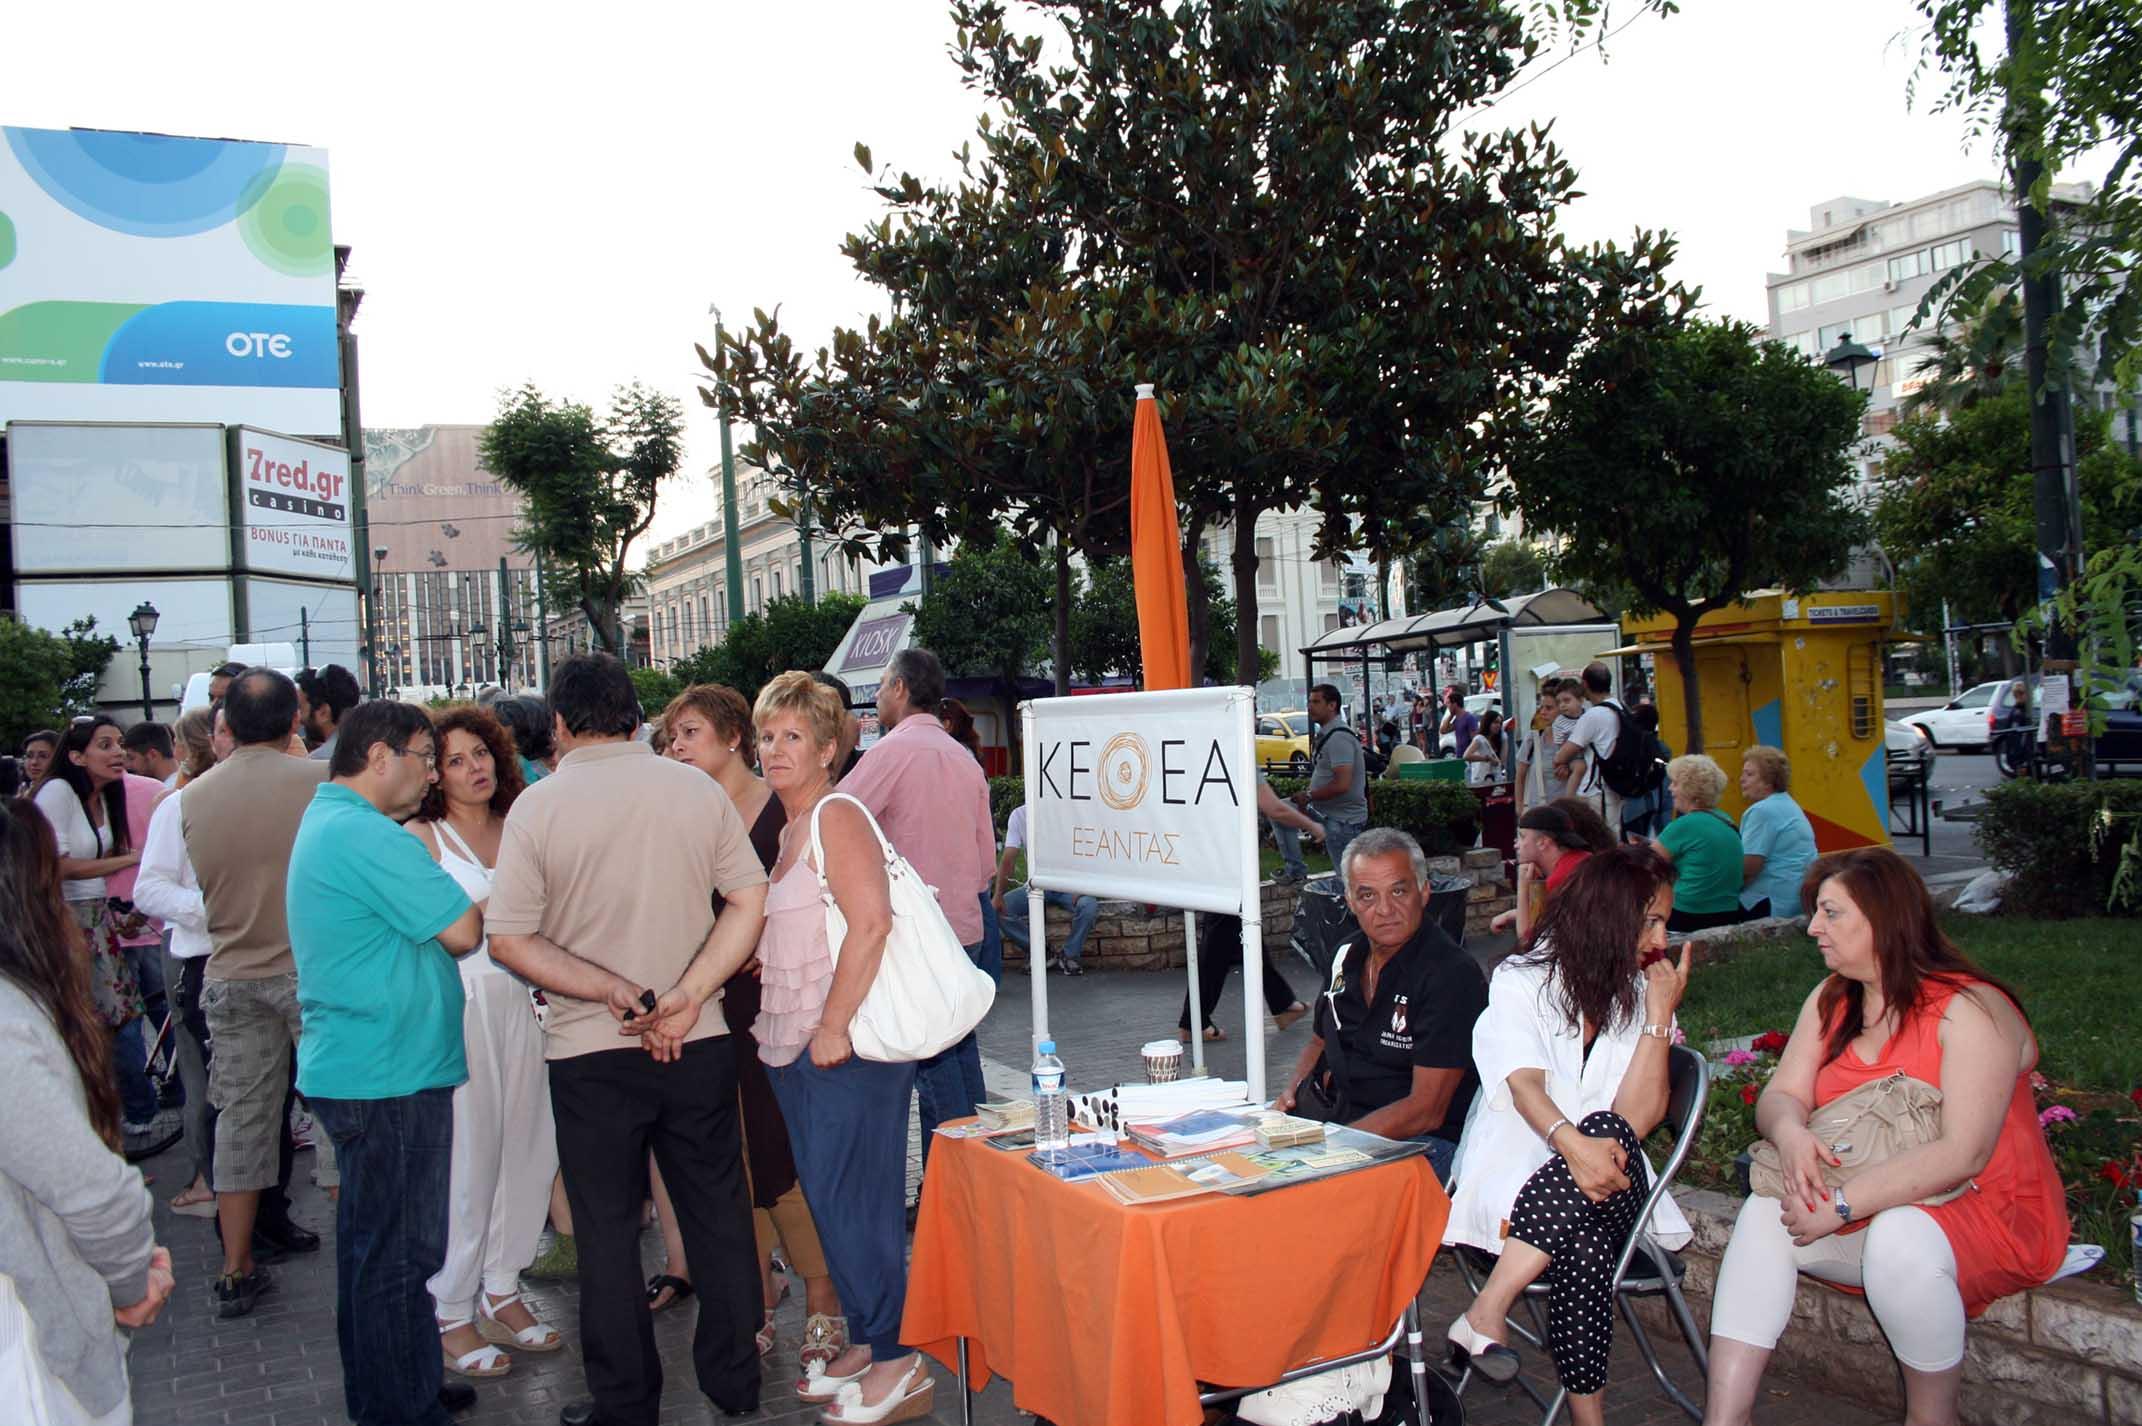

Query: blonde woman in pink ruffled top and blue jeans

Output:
[752, 672, 932, 1422]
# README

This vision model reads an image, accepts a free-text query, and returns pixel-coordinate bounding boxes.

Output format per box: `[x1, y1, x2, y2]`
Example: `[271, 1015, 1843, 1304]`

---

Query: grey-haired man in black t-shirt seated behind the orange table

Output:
[1274, 826, 1487, 1182]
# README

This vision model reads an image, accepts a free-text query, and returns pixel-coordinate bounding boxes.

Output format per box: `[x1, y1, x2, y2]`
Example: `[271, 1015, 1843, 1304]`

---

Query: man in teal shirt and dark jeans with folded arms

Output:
[287, 700, 484, 1422]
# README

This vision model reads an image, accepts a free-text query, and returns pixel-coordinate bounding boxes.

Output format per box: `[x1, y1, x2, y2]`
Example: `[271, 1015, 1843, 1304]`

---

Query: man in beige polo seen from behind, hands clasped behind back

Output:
[484, 653, 767, 1426]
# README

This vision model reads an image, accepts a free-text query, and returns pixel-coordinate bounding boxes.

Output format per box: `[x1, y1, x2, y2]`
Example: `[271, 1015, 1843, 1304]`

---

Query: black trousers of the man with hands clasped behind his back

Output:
[550, 1034, 760, 1426]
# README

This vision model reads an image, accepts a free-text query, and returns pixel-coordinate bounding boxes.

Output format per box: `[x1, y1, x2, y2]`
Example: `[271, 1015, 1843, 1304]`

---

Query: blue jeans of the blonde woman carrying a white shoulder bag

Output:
[767, 1051, 927, 1362]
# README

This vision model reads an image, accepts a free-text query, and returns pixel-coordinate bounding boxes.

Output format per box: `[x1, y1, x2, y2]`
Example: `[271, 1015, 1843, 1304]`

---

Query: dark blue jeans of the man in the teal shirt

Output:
[308, 1088, 454, 1426]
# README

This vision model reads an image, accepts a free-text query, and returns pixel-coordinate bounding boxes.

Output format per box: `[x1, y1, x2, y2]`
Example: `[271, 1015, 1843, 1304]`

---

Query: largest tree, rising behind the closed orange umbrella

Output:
[707, 0, 1686, 679]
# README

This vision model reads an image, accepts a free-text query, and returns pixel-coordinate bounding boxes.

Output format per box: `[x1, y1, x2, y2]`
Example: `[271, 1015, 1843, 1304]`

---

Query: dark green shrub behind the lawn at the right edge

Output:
[1977, 779, 2142, 916]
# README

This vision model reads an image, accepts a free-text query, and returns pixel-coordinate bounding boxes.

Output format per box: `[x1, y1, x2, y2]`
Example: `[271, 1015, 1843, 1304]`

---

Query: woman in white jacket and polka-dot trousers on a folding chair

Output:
[1444, 846, 1690, 1426]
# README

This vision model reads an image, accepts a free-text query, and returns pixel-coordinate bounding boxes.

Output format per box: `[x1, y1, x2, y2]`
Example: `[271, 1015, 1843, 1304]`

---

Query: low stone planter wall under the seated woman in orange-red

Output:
[1639, 1190, 2142, 1426]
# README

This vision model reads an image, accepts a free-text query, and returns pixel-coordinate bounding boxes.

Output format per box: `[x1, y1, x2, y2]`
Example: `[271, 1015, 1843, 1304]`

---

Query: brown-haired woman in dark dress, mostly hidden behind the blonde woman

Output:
[649, 683, 848, 1370]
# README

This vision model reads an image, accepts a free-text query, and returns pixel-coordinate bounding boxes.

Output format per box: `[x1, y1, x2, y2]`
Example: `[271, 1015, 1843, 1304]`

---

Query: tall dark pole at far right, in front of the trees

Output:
[2001, 0, 2086, 758]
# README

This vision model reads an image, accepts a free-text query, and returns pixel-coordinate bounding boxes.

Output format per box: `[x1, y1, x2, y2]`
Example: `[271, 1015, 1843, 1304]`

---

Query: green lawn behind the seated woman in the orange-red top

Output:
[1679, 914, 2142, 1094]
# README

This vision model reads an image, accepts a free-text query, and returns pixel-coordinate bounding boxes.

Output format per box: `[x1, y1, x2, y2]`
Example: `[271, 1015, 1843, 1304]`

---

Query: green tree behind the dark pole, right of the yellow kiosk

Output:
[1874, 391, 2142, 629]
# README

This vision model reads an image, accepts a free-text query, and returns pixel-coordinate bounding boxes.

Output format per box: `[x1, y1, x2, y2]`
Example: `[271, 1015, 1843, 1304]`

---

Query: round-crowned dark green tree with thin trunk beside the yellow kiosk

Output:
[1510, 319, 1866, 752]
